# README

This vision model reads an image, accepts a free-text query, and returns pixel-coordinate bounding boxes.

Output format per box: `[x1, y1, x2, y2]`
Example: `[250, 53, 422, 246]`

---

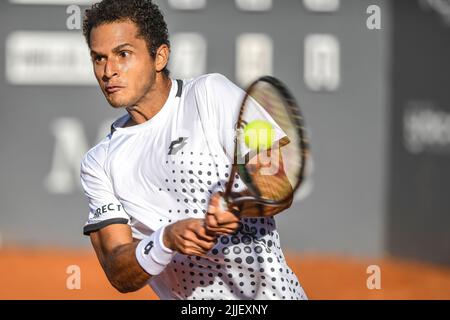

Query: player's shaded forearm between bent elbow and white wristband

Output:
[105, 242, 150, 293]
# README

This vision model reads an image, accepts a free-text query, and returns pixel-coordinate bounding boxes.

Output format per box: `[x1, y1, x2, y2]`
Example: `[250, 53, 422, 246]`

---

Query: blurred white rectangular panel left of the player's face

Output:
[6, 31, 97, 85]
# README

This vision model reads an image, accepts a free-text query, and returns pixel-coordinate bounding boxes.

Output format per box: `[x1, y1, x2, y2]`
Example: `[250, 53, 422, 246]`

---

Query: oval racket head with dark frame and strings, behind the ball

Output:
[224, 76, 309, 206]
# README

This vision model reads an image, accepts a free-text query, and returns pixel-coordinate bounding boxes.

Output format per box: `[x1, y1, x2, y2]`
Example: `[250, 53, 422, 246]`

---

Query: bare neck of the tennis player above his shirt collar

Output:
[124, 76, 172, 127]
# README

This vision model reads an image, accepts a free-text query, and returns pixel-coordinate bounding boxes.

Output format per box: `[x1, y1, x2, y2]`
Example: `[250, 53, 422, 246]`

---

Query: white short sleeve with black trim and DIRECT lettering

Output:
[80, 148, 130, 235]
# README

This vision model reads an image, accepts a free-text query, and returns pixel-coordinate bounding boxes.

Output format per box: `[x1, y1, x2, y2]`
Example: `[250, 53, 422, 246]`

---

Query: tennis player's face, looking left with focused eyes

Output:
[90, 21, 156, 108]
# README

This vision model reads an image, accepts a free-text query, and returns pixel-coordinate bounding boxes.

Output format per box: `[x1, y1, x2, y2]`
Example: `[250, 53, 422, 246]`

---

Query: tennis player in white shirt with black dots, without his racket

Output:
[81, 0, 306, 299]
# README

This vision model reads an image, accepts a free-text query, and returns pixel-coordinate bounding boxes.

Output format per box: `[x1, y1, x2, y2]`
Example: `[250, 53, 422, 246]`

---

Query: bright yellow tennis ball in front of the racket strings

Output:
[244, 120, 275, 150]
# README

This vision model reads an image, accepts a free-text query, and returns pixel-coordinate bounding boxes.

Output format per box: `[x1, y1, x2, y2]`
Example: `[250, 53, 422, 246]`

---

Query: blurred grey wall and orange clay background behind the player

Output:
[0, 0, 450, 299]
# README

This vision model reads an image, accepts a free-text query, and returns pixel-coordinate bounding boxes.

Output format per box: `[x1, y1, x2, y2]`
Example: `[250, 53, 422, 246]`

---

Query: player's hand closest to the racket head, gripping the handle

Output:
[205, 193, 240, 236]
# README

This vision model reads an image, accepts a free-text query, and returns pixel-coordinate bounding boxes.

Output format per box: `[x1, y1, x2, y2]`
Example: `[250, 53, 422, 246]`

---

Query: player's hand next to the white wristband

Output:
[163, 218, 216, 256]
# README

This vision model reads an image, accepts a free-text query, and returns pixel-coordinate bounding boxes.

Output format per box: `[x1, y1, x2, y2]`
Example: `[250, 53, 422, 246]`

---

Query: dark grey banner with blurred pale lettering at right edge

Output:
[386, 0, 450, 265]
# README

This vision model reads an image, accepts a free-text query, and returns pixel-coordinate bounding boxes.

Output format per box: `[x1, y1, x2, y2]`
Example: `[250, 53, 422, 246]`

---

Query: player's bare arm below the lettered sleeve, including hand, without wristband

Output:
[90, 219, 216, 293]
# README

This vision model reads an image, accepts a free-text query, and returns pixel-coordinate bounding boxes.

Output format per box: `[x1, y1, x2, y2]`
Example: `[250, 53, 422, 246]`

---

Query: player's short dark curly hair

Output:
[83, 0, 170, 76]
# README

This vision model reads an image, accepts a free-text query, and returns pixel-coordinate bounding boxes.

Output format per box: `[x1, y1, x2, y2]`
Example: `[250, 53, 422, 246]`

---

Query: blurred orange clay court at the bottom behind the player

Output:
[0, 249, 450, 299]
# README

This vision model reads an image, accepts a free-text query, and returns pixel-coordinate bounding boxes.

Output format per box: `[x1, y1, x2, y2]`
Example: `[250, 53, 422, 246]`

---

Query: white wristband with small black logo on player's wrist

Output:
[136, 227, 175, 276]
